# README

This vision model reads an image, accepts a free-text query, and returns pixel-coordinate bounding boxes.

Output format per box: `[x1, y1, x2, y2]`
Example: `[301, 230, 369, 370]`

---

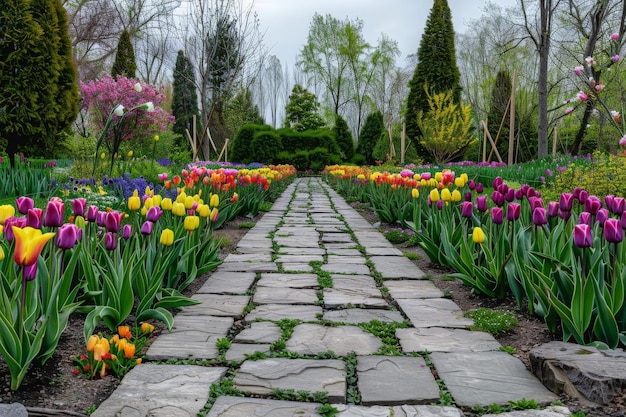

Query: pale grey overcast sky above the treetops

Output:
[254, 0, 516, 68]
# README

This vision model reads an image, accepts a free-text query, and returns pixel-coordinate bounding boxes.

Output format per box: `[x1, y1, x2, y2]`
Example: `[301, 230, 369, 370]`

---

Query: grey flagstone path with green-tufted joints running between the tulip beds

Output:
[92, 178, 567, 417]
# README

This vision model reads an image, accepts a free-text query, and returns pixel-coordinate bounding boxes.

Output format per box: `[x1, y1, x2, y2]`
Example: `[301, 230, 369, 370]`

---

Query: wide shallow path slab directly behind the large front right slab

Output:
[396, 327, 500, 352]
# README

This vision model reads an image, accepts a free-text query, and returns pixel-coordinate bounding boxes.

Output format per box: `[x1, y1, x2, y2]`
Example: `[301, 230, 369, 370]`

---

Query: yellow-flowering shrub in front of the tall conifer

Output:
[417, 87, 476, 164]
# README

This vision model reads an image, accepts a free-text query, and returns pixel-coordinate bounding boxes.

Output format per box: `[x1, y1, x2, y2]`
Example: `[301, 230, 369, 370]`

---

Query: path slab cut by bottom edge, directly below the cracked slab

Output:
[207, 396, 322, 417]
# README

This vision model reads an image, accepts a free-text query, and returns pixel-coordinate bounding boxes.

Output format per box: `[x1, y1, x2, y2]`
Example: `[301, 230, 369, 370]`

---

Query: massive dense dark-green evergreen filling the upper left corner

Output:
[0, 0, 79, 166]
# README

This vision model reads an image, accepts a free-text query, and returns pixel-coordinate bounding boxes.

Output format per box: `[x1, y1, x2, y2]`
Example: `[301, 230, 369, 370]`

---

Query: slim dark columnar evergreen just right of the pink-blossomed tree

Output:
[172, 51, 200, 146]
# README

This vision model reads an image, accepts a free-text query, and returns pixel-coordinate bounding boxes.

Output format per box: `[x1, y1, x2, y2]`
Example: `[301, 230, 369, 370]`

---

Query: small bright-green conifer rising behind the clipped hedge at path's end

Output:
[285, 84, 325, 132]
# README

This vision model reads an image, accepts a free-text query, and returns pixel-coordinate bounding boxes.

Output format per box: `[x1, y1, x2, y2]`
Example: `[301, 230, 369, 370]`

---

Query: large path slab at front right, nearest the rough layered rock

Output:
[430, 352, 559, 407]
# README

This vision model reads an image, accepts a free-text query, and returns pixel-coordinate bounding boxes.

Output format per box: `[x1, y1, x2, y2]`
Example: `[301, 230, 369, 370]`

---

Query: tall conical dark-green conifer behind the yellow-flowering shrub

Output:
[406, 0, 461, 157]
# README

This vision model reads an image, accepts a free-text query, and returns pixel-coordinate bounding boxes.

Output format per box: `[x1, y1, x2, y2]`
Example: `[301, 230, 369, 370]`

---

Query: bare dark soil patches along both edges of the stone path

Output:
[0, 205, 626, 417]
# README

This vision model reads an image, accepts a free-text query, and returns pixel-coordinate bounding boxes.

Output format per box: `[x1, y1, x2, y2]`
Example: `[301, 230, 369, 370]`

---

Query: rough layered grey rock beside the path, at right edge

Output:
[529, 342, 626, 405]
